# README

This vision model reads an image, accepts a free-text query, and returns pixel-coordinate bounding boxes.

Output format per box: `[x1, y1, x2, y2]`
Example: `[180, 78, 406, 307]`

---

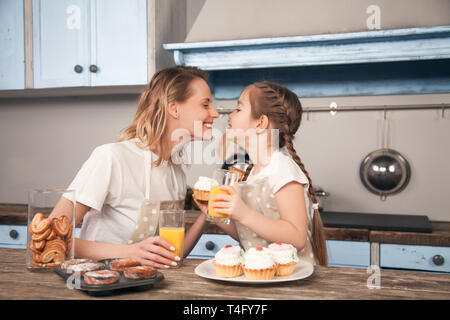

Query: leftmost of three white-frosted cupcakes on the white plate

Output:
[212, 245, 244, 278]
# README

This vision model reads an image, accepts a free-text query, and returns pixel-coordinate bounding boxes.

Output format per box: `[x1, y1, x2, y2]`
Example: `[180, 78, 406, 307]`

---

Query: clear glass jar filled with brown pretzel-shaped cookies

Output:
[26, 189, 76, 271]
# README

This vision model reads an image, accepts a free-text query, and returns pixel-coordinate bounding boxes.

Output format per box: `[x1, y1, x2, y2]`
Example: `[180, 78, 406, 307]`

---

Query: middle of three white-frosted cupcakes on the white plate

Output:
[244, 247, 277, 280]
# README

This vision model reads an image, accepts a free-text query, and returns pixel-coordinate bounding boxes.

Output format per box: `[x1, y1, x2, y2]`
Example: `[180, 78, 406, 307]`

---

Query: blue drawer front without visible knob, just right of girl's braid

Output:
[326, 240, 370, 268]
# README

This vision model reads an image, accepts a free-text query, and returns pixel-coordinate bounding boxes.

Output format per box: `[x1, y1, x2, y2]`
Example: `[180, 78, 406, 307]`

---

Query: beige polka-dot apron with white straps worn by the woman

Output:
[128, 150, 184, 244]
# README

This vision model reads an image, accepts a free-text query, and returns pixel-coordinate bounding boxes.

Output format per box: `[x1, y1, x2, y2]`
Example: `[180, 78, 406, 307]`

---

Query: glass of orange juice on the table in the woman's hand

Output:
[159, 209, 185, 268]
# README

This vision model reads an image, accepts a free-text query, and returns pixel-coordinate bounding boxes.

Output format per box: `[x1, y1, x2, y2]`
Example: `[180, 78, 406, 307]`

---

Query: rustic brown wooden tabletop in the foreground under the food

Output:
[0, 249, 450, 300]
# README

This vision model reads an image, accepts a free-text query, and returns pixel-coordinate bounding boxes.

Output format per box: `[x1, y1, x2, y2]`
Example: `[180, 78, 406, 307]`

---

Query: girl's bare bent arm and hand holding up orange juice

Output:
[214, 182, 308, 250]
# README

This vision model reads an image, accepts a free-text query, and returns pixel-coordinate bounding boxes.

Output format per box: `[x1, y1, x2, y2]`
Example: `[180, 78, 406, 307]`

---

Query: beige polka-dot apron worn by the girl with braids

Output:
[235, 177, 317, 264]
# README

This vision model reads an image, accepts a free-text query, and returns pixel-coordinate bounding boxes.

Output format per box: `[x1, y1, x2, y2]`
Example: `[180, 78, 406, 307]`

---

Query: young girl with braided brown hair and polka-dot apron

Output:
[213, 81, 327, 265]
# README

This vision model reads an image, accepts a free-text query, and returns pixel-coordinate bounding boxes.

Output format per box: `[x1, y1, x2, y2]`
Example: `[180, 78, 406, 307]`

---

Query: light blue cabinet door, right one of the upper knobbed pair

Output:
[91, 0, 147, 86]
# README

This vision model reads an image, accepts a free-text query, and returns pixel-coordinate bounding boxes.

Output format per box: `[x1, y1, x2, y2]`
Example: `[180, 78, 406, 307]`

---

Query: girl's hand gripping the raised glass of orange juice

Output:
[212, 186, 250, 222]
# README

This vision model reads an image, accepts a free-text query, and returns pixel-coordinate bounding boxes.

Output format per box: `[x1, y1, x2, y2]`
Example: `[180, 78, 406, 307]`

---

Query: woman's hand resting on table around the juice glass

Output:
[128, 236, 180, 268]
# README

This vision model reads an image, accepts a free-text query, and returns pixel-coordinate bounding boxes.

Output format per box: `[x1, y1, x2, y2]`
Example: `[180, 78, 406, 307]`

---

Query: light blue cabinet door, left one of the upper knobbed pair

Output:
[33, 0, 90, 88]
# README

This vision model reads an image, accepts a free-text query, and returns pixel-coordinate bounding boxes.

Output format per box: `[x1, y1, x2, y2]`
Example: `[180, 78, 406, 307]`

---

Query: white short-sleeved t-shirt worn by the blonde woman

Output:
[65, 140, 186, 243]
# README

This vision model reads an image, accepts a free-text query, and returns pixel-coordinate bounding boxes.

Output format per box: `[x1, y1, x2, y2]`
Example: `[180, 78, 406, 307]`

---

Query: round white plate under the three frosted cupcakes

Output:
[195, 259, 314, 284]
